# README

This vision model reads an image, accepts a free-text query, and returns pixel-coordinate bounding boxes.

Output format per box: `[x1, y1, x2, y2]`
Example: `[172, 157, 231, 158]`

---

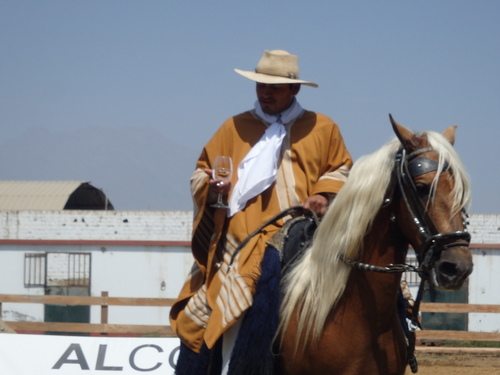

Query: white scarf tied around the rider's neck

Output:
[227, 99, 303, 217]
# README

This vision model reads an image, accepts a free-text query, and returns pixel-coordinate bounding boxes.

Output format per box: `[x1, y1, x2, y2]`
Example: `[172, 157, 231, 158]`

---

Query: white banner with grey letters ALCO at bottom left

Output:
[0, 333, 179, 375]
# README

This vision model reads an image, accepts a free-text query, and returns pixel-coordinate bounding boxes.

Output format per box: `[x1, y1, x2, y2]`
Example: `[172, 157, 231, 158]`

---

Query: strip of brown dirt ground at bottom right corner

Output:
[405, 353, 500, 375]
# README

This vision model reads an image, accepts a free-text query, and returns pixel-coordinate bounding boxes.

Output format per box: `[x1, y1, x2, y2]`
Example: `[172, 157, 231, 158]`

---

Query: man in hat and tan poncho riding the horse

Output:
[170, 50, 352, 375]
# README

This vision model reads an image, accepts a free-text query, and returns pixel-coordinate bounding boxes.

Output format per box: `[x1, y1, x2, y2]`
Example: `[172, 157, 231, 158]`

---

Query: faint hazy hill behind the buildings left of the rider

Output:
[0, 127, 200, 210]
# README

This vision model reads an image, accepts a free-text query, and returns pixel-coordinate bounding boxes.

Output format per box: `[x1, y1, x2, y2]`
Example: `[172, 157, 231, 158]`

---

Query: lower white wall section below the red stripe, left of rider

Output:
[0, 245, 193, 325]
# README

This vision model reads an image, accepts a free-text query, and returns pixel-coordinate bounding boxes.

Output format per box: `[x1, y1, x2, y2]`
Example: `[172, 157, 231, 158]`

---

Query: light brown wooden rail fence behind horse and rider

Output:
[0, 292, 500, 341]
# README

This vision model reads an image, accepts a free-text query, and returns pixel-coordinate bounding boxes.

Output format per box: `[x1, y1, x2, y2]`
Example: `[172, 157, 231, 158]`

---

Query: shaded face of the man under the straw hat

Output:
[257, 82, 300, 115]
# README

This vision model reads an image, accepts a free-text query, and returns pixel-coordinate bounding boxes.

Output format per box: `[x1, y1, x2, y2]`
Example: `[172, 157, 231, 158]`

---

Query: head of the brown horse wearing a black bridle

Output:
[390, 116, 473, 290]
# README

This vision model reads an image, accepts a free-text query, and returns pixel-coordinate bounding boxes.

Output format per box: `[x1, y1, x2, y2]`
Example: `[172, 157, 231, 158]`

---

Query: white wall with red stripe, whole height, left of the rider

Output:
[0, 211, 193, 324]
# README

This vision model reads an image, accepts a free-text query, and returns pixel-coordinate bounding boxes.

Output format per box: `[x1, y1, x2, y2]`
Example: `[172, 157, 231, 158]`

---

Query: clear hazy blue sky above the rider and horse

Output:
[0, 0, 500, 214]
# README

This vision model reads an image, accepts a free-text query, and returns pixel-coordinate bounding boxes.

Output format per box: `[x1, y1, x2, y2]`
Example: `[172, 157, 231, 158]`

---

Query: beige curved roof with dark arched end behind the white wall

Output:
[0, 181, 114, 211]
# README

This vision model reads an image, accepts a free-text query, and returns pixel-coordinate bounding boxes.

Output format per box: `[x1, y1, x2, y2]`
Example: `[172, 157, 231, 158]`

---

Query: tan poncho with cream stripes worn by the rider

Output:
[170, 111, 352, 352]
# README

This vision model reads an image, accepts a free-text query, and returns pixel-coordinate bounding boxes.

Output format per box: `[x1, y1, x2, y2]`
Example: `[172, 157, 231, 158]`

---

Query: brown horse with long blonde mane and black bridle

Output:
[279, 116, 472, 375]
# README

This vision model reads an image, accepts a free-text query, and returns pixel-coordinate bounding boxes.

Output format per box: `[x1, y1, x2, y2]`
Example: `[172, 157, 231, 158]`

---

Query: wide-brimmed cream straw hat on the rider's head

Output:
[234, 49, 318, 87]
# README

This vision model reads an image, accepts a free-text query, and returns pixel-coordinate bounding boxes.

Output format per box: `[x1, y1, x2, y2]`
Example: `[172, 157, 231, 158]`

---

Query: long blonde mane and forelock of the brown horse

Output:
[279, 131, 470, 347]
